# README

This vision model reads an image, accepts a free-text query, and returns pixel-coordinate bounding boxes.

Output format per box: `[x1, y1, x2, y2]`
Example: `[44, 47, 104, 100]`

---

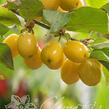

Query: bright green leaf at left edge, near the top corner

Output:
[0, 7, 20, 26]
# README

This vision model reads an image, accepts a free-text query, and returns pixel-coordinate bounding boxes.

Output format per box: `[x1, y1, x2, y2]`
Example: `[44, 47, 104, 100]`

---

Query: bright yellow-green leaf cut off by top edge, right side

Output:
[86, 0, 107, 8]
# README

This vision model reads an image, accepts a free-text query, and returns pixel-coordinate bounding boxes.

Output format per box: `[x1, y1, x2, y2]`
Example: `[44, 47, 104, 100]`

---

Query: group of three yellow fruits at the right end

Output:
[61, 41, 102, 86]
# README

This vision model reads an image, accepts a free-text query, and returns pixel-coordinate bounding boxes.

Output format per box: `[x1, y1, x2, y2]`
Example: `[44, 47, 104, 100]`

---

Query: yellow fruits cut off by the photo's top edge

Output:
[41, 0, 82, 12]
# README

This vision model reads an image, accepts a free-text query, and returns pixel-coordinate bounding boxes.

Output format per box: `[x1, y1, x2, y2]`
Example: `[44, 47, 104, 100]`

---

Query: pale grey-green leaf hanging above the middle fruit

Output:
[43, 10, 70, 32]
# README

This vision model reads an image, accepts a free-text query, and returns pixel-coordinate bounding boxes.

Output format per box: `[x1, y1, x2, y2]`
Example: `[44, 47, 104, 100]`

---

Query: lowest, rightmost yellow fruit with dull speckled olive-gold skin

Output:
[78, 59, 102, 86]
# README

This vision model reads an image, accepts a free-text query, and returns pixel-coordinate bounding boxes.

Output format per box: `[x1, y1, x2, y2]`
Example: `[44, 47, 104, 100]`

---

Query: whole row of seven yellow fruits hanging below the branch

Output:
[3, 32, 102, 86]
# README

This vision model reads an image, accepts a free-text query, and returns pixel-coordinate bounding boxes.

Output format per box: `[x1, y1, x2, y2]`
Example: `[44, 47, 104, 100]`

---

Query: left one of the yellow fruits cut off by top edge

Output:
[41, 0, 60, 10]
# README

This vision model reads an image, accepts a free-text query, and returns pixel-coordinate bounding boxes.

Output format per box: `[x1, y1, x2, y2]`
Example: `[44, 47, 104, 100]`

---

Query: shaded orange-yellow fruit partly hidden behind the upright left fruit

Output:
[24, 49, 42, 70]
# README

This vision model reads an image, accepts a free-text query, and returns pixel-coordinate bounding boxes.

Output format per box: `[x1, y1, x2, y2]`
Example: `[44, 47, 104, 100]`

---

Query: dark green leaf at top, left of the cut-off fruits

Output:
[19, 0, 44, 20]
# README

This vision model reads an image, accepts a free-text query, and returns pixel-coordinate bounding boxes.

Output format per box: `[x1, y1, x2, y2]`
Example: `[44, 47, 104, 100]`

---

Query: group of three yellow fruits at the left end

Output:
[3, 32, 43, 69]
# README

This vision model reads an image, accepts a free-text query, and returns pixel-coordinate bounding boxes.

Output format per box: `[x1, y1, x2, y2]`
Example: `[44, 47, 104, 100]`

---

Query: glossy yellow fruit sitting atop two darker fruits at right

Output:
[64, 41, 89, 63]
